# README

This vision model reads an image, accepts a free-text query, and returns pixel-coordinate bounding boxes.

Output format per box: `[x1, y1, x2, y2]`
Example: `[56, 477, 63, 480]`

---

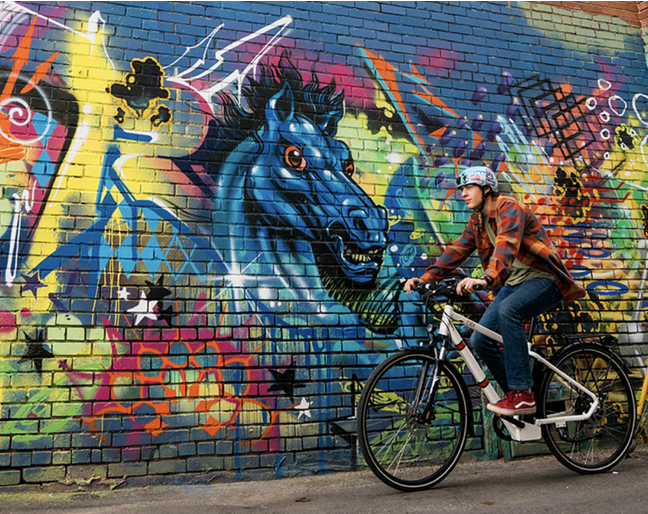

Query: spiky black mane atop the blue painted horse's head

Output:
[219, 52, 344, 147]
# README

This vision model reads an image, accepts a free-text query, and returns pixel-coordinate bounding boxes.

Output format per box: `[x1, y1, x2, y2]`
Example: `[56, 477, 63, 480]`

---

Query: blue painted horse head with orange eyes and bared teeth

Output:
[195, 55, 396, 331]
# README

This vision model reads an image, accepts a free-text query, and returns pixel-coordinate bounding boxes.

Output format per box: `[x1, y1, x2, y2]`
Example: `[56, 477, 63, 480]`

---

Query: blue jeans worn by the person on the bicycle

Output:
[470, 278, 563, 393]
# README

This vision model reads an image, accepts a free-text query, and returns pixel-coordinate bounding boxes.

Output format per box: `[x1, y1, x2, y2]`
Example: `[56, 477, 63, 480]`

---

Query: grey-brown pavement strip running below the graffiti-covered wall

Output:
[0, 446, 648, 514]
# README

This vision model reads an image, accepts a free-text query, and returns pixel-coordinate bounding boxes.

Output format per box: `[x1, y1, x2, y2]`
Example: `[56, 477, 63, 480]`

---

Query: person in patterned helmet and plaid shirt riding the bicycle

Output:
[405, 166, 585, 416]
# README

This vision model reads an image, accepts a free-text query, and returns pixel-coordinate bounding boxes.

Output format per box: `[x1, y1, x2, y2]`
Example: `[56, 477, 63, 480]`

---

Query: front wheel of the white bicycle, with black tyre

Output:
[357, 349, 470, 491]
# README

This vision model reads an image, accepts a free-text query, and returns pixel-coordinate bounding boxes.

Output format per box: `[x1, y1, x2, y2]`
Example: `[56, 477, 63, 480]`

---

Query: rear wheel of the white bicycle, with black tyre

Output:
[538, 342, 637, 474]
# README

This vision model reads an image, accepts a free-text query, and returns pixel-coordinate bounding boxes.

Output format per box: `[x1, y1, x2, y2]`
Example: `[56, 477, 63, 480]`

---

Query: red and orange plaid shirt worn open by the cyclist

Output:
[421, 196, 585, 302]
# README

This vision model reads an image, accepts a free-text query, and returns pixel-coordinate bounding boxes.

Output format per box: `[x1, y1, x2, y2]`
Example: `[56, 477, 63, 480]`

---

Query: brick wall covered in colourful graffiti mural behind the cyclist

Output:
[0, 2, 648, 485]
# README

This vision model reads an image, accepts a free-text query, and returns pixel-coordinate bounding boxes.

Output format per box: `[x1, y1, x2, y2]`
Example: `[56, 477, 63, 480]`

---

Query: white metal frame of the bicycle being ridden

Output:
[439, 305, 599, 441]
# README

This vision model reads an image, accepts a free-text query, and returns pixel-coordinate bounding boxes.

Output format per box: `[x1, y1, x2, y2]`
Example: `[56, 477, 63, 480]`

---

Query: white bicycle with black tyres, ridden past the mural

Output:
[357, 280, 637, 491]
